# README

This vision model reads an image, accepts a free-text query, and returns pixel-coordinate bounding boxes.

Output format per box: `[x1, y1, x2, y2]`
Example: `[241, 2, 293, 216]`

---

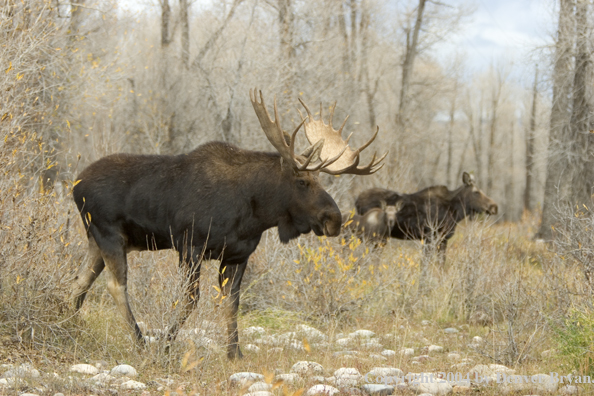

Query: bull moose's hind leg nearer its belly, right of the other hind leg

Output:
[103, 249, 144, 341]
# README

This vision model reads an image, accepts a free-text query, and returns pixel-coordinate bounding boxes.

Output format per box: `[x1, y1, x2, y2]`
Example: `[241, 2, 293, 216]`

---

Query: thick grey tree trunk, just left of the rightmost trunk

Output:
[535, 0, 575, 240]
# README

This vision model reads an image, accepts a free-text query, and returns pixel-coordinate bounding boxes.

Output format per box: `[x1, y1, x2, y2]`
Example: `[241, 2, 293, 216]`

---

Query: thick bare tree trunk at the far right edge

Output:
[571, 0, 594, 208]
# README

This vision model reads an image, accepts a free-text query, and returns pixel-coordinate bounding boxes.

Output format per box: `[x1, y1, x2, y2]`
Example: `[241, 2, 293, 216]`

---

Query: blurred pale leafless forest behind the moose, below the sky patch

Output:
[0, 0, 572, 226]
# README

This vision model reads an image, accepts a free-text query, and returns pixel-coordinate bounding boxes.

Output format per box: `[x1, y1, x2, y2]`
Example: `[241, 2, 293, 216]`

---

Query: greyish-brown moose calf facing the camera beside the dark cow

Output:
[343, 200, 402, 243]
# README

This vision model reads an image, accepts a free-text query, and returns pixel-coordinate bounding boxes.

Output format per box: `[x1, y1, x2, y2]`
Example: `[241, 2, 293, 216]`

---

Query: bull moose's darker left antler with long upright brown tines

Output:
[250, 89, 346, 171]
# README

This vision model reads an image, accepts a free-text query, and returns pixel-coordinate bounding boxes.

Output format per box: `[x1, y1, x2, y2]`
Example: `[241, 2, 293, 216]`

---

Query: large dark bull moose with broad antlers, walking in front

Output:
[72, 90, 385, 359]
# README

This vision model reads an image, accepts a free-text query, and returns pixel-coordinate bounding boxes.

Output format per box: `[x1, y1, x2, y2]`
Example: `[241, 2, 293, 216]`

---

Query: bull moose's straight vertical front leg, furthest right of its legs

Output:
[219, 260, 247, 359]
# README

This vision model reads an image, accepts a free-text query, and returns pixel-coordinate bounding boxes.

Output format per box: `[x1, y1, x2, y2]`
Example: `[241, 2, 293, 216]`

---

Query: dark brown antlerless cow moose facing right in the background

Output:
[356, 172, 497, 260]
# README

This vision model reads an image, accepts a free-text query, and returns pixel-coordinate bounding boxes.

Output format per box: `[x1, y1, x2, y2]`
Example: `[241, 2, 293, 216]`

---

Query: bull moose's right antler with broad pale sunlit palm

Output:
[299, 99, 388, 175]
